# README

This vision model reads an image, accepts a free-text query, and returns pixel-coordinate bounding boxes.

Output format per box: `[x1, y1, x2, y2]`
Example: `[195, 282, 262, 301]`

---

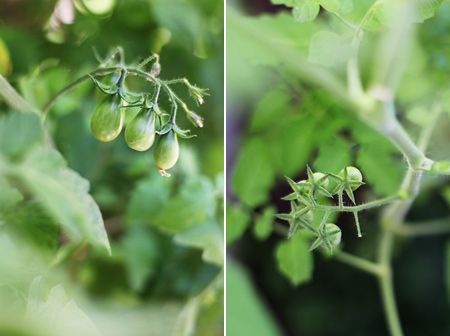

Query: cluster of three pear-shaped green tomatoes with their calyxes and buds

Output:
[85, 49, 206, 176]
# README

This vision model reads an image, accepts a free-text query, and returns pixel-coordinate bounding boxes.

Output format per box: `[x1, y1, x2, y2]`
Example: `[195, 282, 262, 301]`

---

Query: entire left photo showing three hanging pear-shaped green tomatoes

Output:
[0, 0, 224, 336]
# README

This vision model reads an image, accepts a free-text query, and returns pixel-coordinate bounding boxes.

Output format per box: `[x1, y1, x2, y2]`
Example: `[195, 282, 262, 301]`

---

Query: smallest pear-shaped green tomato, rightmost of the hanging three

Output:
[153, 130, 180, 169]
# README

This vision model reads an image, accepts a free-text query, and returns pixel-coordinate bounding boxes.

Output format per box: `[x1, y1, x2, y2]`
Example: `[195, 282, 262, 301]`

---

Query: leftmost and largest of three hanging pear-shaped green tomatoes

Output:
[91, 93, 124, 142]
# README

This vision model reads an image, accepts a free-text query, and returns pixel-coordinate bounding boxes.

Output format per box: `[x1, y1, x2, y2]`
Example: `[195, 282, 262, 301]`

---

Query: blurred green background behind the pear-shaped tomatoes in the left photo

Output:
[0, 0, 224, 336]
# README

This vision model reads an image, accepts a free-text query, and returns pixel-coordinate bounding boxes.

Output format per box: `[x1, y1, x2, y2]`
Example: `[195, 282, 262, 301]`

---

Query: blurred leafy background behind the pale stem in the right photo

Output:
[226, 0, 450, 336]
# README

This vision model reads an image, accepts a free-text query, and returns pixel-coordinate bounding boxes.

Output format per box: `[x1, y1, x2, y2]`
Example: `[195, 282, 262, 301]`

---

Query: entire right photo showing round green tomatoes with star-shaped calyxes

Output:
[226, 0, 450, 336]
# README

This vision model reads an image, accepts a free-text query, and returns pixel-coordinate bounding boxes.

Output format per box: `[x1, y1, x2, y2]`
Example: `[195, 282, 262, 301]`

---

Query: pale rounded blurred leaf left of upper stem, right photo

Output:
[308, 31, 350, 67]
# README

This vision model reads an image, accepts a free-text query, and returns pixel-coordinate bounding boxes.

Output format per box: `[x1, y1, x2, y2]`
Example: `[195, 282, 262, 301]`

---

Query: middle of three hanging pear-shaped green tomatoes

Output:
[125, 108, 156, 151]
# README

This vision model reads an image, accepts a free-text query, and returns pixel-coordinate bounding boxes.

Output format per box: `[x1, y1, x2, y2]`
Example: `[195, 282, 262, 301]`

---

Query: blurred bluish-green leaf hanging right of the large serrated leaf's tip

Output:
[121, 222, 159, 292]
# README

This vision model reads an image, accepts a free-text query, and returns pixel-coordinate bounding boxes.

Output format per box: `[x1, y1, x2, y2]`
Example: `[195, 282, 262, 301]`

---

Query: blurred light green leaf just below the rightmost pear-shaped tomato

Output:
[149, 176, 217, 234]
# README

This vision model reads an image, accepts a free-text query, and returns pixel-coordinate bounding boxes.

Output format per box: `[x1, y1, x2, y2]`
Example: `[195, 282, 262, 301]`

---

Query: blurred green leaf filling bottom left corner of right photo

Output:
[226, 260, 282, 336]
